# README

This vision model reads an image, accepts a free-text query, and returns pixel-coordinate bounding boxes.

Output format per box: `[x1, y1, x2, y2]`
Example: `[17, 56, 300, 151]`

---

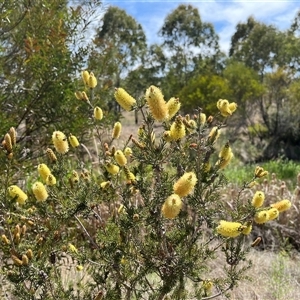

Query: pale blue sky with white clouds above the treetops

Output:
[105, 0, 300, 52]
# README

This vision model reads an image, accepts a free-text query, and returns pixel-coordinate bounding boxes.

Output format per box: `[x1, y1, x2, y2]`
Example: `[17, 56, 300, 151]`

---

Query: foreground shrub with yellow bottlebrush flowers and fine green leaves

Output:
[0, 71, 291, 300]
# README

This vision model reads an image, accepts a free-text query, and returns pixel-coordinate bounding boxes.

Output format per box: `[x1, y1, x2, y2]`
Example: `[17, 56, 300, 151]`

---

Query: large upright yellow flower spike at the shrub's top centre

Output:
[145, 85, 168, 121]
